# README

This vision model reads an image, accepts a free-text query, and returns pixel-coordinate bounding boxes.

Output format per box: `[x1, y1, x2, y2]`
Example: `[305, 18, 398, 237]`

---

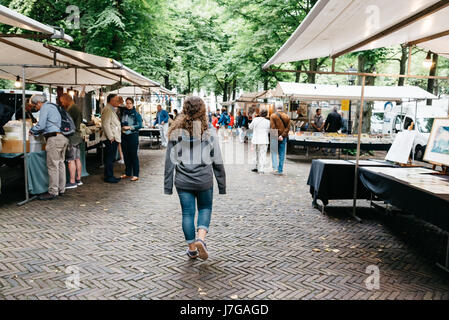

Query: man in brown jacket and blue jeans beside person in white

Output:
[270, 106, 290, 175]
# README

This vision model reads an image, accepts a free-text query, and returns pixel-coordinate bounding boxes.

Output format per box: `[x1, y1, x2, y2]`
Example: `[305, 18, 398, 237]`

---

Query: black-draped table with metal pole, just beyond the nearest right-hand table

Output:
[307, 160, 394, 206]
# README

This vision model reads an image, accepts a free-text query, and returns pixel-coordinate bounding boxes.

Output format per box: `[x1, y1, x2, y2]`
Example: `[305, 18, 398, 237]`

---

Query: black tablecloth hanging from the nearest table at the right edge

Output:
[359, 168, 449, 231]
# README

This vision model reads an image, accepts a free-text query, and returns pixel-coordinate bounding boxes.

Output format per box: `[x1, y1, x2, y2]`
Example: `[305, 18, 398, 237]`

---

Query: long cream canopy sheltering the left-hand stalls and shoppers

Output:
[0, 38, 161, 88]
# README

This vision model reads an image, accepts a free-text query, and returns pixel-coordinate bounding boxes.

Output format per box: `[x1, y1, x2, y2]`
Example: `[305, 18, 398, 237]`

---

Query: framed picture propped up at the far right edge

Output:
[424, 118, 449, 167]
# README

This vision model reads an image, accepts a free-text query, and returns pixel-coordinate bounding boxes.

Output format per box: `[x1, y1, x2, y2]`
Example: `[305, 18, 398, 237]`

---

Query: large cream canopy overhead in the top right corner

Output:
[264, 0, 449, 69]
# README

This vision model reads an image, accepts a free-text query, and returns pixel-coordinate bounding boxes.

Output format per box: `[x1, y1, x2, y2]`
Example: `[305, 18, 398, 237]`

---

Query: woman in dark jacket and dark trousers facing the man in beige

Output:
[121, 98, 143, 181]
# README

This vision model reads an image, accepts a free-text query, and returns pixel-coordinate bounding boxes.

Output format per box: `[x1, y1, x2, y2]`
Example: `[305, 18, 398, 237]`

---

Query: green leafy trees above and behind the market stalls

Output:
[0, 0, 449, 100]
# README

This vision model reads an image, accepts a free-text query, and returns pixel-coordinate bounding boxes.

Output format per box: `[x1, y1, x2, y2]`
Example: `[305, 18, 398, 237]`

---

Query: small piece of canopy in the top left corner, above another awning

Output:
[0, 5, 73, 42]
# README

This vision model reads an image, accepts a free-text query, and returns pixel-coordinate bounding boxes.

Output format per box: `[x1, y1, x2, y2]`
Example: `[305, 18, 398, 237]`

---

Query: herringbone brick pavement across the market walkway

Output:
[0, 140, 449, 300]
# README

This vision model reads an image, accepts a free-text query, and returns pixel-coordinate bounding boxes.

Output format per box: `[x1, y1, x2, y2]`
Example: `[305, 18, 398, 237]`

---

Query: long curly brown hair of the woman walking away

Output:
[168, 97, 208, 138]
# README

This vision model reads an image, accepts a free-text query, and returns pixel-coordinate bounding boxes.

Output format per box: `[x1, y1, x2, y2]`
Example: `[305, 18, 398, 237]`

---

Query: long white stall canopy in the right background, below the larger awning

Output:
[274, 82, 438, 101]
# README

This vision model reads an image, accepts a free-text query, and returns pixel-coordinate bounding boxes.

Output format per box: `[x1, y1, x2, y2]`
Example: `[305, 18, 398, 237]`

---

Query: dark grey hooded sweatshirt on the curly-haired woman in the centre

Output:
[164, 132, 226, 194]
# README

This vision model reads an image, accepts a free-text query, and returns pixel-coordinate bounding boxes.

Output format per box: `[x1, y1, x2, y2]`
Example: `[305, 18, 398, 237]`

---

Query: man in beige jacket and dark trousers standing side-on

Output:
[101, 94, 123, 183]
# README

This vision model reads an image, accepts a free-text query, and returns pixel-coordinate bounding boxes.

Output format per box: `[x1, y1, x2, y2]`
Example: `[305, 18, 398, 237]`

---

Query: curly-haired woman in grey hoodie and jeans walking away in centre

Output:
[164, 97, 226, 260]
